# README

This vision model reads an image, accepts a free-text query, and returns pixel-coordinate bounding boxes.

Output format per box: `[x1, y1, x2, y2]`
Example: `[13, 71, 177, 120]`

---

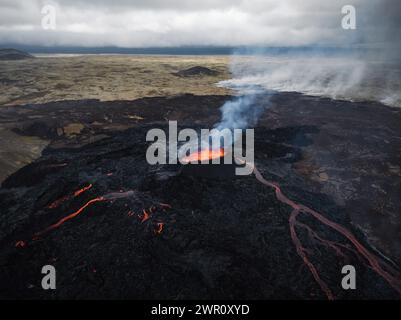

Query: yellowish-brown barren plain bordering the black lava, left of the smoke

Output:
[0, 55, 229, 183]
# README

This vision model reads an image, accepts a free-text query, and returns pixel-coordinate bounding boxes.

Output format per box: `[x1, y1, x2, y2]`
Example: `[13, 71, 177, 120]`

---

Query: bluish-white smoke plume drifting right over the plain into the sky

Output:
[218, 0, 401, 109]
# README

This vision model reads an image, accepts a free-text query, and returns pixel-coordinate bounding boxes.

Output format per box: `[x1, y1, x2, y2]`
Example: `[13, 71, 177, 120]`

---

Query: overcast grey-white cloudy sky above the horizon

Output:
[0, 0, 401, 47]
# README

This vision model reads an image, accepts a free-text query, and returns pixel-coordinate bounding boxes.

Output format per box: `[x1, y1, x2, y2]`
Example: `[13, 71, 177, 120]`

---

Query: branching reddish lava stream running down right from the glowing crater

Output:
[253, 166, 401, 300]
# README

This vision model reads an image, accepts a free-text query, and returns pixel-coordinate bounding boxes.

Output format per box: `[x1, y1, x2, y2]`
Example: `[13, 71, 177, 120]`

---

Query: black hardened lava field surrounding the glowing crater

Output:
[0, 93, 401, 299]
